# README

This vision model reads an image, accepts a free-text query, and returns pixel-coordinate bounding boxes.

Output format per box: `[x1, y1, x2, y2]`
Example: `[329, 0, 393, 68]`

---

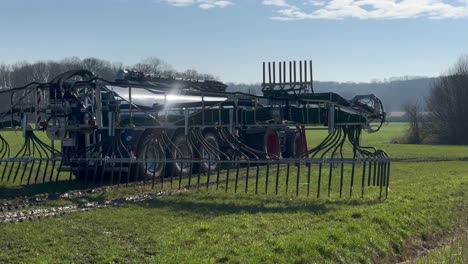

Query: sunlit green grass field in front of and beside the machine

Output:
[0, 124, 468, 263]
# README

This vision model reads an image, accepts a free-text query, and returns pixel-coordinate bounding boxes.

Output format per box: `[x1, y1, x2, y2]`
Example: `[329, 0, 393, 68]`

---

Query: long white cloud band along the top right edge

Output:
[262, 0, 468, 20]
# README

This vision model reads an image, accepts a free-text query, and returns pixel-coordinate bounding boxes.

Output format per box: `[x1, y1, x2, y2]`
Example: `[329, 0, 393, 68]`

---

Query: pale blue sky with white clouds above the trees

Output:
[0, 0, 468, 83]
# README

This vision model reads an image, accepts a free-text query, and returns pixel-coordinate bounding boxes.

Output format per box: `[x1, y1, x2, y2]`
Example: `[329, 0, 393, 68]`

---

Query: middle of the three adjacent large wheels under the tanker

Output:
[168, 133, 193, 176]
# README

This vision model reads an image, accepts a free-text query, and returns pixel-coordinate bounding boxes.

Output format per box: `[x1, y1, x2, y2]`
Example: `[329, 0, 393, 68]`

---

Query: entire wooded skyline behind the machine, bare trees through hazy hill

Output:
[0, 57, 436, 112]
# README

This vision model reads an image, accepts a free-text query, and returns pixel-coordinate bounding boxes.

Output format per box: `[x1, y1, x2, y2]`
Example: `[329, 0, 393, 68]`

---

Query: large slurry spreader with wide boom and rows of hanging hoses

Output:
[0, 61, 390, 197]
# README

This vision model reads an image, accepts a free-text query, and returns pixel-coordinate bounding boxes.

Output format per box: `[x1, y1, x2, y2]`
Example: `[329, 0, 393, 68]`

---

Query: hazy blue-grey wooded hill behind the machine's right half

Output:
[228, 77, 437, 112]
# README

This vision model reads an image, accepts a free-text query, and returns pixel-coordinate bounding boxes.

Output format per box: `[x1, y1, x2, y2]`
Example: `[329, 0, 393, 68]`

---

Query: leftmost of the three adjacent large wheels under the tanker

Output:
[136, 132, 165, 180]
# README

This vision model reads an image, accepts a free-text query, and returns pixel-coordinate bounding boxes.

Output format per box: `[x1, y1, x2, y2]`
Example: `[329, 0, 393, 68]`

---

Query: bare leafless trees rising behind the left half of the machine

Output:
[0, 57, 216, 89]
